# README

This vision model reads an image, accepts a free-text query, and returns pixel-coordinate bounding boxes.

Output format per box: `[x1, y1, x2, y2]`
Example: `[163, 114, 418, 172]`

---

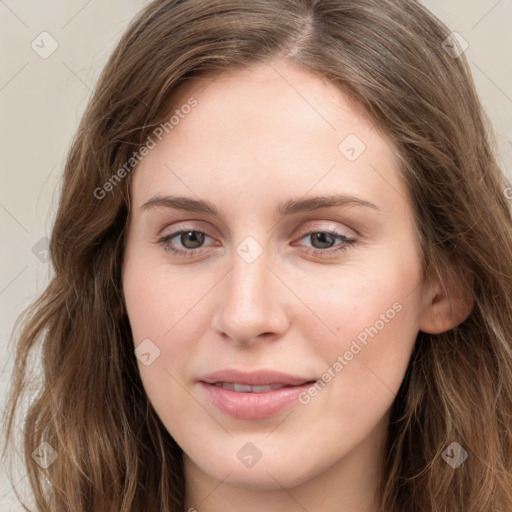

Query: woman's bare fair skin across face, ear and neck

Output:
[123, 61, 467, 512]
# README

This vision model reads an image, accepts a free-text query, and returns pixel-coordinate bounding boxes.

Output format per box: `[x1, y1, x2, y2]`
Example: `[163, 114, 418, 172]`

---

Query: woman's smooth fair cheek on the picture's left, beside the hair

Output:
[123, 254, 215, 396]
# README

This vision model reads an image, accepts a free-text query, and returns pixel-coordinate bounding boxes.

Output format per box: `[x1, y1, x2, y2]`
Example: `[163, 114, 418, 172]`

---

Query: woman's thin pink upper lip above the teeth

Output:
[199, 368, 315, 386]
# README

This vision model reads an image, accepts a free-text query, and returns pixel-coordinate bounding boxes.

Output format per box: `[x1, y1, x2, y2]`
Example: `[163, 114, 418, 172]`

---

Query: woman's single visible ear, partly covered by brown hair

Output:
[419, 273, 474, 334]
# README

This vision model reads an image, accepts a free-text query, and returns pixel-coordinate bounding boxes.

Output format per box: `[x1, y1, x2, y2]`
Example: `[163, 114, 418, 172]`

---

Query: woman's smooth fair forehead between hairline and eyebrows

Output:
[129, 62, 405, 216]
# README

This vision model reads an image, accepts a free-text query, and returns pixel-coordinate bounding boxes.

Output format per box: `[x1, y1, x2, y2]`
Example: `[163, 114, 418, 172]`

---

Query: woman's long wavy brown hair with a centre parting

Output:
[4, 0, 512, 512]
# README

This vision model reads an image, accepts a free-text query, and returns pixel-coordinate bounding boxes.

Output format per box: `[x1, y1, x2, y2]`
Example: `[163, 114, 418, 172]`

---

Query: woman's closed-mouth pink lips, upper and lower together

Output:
[199, 369, 316, 420]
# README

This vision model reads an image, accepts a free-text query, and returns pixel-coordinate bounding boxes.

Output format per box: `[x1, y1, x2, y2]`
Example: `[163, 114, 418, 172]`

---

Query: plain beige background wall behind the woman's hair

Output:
[0, 0, 512, 512]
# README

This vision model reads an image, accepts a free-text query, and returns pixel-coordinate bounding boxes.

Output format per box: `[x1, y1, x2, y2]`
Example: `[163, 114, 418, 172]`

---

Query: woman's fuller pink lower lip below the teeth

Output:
[200, 382, 313, 420]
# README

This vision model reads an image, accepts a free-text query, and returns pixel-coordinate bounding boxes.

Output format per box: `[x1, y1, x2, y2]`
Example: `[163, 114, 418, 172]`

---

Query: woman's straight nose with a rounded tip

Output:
[212, 242, 290, 346]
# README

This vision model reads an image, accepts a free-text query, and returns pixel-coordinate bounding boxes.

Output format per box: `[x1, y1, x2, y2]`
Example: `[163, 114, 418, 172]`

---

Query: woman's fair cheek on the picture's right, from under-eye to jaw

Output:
[304, 247, 422, 424]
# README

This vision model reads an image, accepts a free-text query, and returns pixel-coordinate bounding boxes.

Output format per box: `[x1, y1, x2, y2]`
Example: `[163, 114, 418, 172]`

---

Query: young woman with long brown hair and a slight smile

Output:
[7, 0, 512, 512]
